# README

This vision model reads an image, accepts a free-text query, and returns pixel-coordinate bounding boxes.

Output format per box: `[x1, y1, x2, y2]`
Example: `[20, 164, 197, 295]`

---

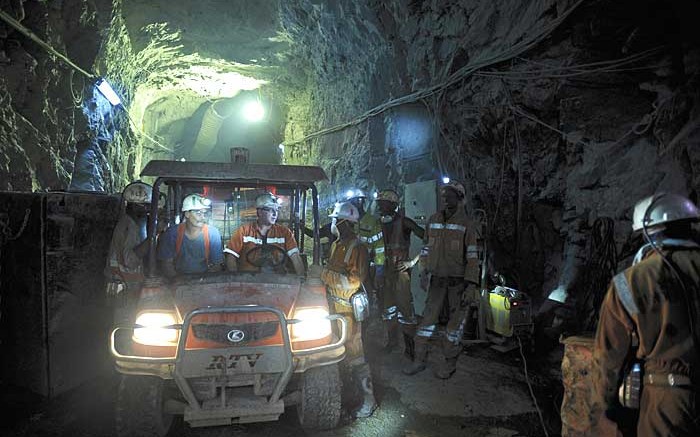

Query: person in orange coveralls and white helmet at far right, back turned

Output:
[592, 194, 700, 436]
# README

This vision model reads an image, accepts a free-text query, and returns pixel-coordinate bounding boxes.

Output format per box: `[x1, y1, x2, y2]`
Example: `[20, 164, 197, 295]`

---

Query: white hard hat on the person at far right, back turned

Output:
[632, 193, 700, 231]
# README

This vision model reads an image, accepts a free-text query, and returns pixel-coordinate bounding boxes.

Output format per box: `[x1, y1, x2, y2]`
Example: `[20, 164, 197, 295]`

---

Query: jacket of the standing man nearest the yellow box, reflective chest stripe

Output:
[424, 208, 479, 284]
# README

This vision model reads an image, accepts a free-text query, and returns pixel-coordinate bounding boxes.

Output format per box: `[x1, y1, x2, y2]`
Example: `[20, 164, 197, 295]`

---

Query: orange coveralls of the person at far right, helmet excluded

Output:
[591, 242, 700, 436]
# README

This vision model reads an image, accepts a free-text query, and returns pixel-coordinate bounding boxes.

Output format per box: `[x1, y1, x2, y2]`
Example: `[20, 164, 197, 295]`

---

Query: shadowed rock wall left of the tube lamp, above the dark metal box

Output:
[0, 0, 111, 191]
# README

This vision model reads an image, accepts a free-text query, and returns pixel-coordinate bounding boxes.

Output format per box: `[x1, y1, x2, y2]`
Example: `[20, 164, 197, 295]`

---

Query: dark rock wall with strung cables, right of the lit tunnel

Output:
[282, 0, 700, 304]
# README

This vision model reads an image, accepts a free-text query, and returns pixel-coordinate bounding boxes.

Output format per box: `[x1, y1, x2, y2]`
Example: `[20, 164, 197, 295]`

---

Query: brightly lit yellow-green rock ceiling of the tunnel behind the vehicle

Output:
[98, 0, 289, 169]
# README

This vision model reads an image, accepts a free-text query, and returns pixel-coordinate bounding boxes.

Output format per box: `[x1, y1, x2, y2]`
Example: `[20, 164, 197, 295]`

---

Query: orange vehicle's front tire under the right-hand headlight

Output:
[297, 364, 341, 431]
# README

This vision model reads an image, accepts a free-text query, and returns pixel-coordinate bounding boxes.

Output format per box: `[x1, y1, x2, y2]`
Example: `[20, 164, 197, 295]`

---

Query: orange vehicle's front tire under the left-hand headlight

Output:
[115, 375, 173, 437]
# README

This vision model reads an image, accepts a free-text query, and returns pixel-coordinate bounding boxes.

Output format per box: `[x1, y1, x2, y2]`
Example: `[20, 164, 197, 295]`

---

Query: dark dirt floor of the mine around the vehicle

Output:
[0, 330, 561, 437]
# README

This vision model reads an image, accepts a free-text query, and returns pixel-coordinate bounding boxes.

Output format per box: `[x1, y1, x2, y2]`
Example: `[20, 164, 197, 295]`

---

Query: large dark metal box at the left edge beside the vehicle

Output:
[0, 192, 119, 397]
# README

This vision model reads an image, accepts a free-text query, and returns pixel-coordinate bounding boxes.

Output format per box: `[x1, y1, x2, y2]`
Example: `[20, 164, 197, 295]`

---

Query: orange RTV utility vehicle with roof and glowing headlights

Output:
[110, 161, 347, 436]
